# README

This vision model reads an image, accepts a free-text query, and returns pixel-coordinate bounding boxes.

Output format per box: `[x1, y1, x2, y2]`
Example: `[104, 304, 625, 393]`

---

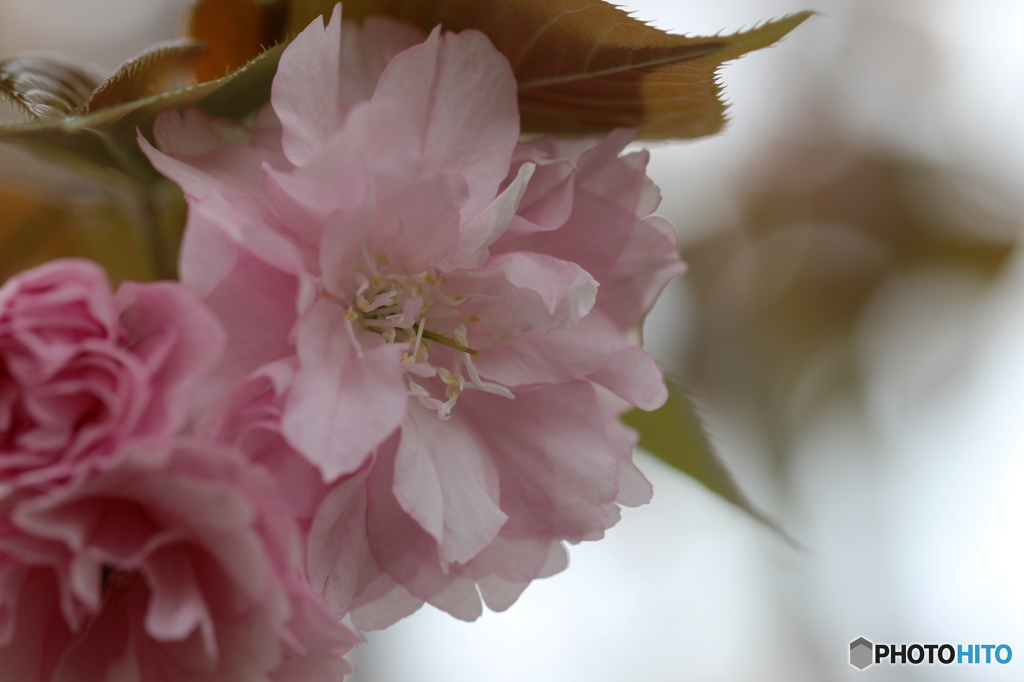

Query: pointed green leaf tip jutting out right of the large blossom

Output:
[623, 382, 793, 542]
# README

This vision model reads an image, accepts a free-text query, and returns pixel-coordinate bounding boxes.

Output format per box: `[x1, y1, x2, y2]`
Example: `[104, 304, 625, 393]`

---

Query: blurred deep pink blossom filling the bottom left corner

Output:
[0, 440, 356, 682]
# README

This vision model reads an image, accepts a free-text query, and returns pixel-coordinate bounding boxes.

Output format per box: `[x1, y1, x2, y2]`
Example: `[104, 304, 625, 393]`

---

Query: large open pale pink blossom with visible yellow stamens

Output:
[140, 5, 682, 627]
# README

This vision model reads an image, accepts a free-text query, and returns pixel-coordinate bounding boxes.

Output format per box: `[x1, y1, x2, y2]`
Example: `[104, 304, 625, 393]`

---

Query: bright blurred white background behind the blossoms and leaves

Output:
[0, 0, 1024, 682]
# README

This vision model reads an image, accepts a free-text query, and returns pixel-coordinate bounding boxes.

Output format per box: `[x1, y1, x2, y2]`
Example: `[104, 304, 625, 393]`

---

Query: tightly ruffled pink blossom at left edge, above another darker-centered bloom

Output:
[0, 260, 224, 492]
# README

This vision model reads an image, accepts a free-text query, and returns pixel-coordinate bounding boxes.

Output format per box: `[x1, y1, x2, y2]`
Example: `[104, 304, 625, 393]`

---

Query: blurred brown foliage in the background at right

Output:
[685, 126, 1016, 471]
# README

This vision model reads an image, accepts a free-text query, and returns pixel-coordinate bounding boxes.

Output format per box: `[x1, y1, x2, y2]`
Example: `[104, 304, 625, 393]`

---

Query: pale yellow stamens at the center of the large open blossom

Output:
[333, 253, 514, 420]
